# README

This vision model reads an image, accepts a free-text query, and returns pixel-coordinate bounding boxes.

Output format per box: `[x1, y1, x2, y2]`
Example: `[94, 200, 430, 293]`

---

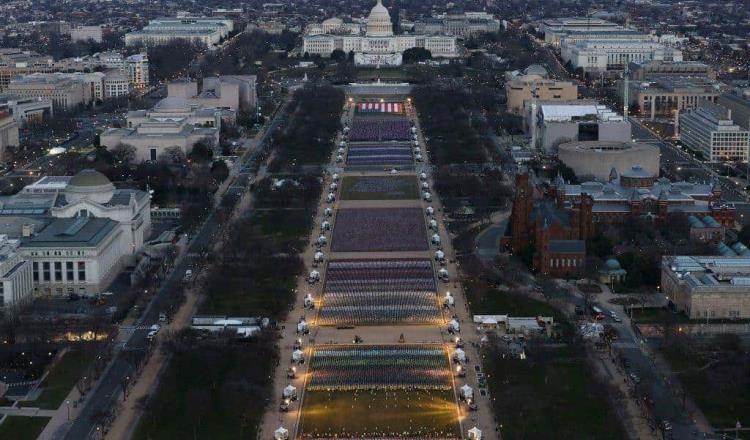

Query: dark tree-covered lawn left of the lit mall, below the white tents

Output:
[133, 338, 276, 440]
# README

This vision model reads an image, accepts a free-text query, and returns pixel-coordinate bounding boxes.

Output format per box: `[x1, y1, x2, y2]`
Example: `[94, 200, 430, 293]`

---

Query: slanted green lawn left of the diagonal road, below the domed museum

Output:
[19, 350, 93, 409]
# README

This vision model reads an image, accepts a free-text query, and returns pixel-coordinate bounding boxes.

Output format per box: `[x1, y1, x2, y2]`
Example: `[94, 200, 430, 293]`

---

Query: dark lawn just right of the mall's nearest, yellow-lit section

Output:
[484, 347, 625, 440]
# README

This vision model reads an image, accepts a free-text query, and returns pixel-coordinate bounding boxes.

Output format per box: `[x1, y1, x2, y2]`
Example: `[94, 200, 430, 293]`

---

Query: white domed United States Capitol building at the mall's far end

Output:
[302, 0, 459, 66]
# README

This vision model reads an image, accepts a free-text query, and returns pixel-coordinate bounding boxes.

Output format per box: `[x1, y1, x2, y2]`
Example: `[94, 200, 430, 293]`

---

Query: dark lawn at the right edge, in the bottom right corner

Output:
[661, 348, 750, 428]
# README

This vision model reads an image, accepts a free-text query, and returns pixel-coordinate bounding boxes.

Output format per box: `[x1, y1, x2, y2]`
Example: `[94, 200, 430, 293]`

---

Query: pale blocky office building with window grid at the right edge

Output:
[679, 102, 750, 162]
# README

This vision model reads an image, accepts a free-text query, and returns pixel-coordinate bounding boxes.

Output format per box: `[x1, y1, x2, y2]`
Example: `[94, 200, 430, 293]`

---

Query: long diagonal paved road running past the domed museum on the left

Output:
[63, 97, 287, 440]
